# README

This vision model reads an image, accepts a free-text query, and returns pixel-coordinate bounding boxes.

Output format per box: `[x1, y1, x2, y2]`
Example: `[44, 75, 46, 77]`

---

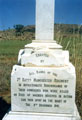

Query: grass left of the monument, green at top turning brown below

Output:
[0, 40, 31, 99]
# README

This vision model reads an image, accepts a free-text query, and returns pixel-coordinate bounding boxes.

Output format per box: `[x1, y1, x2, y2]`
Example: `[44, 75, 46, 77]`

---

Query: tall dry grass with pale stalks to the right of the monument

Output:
[57, 34, 82, 118]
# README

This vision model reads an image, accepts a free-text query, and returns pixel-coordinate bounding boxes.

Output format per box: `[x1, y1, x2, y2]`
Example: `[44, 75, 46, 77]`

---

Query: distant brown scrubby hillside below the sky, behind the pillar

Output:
[0, 24, 82, 40]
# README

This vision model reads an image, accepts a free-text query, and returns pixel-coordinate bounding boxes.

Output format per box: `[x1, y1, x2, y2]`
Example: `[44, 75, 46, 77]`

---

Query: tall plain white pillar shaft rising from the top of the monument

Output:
[36, 0, 54, 42]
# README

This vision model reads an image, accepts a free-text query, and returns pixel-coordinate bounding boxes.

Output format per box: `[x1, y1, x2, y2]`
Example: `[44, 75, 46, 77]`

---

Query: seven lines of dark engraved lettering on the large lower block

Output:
[13, 69, 73, 113]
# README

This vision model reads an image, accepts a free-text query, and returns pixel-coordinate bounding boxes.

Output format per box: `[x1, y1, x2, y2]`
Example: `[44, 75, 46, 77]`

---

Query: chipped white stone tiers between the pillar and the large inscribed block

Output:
[18, 42, 69, 67]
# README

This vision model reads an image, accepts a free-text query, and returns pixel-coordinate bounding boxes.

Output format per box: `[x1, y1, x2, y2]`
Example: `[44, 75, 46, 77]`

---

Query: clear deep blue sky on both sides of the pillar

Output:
[0, 0, 82, 29]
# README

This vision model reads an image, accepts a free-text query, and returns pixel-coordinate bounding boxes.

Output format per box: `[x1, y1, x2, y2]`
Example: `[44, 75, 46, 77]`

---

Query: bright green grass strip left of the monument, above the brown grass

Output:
[0, 40, 30, 57]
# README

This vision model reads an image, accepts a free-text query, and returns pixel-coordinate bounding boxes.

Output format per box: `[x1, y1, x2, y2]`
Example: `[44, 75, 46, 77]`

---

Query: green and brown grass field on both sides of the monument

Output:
[0, 34, 82, 119]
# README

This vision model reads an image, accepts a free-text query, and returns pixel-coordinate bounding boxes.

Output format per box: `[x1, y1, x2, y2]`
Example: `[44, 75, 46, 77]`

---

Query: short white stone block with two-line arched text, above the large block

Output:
[21, 49, 69, 67]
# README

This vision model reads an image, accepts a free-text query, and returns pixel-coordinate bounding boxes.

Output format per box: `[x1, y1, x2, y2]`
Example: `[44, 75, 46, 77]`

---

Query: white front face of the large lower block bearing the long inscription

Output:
[12, 67, 74, 113]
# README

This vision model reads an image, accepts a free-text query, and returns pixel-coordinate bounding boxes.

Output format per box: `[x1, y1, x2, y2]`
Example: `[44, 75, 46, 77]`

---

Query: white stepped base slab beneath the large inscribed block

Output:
[2, 104, 81, 120]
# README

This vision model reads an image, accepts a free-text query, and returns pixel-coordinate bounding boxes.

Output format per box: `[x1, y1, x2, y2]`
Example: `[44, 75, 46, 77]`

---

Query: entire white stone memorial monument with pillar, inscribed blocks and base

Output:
[3, 0, 80, 120]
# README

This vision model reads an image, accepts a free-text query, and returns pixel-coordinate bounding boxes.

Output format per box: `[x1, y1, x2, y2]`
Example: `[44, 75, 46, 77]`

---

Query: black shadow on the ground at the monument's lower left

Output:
[0, 97, 10, 120]
